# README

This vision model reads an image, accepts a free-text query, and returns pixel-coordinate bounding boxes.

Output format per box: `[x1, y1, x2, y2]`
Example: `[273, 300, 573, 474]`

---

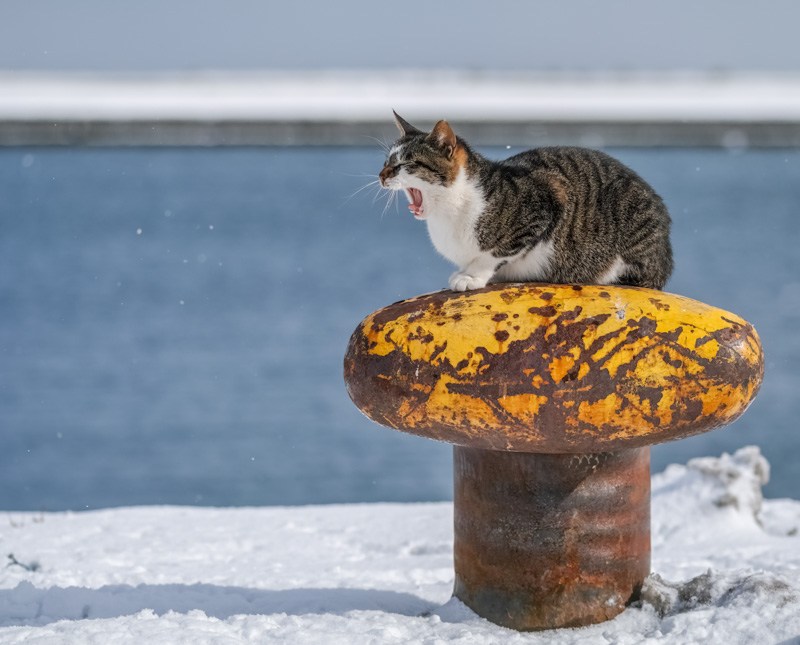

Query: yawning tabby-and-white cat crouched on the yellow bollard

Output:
[379, 112, 673, 291]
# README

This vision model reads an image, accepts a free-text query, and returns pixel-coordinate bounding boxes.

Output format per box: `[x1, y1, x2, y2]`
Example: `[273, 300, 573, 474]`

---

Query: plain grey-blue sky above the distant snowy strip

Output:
[0, 0, 800, 71]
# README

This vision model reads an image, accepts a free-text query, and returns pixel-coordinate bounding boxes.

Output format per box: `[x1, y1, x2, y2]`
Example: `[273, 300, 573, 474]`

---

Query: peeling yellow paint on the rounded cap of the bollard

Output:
[351, 284, 763, 451]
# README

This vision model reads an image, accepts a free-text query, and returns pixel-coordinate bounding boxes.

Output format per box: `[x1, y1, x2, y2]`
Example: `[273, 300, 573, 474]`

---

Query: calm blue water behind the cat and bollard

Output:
[0, 148, 800, 510]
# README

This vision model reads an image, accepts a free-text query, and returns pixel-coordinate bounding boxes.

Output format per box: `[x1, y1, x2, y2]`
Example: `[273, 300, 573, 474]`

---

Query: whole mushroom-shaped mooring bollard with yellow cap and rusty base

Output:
[344, 283, 763, 630]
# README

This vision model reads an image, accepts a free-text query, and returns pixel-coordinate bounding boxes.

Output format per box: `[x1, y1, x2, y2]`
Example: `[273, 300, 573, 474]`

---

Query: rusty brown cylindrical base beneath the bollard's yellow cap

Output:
[453, 446, 650, 631]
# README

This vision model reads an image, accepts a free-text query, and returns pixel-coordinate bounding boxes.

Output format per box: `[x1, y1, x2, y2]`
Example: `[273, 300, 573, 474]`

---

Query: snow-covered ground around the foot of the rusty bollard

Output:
[0, 447, 800, 645]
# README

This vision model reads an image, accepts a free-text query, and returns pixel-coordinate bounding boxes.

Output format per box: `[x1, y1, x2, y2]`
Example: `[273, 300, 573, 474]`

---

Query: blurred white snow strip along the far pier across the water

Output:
[0, 70, 800, 123]
